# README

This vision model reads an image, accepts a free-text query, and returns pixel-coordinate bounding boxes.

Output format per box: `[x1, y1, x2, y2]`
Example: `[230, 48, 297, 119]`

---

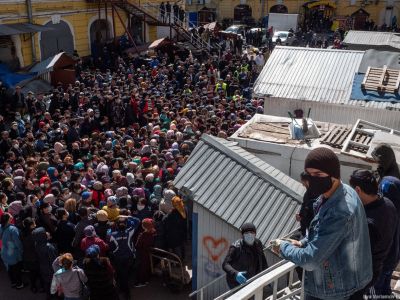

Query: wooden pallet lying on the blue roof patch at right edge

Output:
[361, 66, 400, 94]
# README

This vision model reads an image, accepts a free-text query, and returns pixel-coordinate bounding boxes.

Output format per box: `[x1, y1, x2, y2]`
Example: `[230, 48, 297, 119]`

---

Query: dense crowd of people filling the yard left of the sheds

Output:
[0, 37, 263, 300]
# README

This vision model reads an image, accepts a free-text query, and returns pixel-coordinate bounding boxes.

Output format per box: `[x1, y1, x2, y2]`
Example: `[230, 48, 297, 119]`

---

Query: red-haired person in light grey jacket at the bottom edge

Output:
[51, 253, 87, 300]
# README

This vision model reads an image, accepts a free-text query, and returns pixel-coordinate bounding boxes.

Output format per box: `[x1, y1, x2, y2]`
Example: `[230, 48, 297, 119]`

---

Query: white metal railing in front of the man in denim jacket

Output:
[225, 261, 304, 300]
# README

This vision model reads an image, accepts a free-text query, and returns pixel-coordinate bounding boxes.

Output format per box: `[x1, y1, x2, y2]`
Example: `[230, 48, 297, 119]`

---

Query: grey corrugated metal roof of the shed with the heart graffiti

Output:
[174, 135, 305, 244]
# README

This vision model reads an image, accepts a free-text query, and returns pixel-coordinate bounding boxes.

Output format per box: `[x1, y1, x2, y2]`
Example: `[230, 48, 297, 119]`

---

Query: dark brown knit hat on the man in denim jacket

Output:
[304, 147, 340, 179]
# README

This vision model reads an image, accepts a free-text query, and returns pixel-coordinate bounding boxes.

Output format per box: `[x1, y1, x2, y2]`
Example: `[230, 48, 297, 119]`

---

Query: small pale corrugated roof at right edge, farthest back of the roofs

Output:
[343, 30, 400, 49]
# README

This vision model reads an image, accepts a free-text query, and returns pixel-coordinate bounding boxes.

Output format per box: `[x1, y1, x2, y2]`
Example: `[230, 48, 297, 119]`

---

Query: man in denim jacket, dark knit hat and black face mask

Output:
[275, 148, 372, 300]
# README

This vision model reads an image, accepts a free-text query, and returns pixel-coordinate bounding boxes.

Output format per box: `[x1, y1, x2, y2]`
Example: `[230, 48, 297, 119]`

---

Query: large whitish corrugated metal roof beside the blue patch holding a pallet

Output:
[254, 46, 364, 103]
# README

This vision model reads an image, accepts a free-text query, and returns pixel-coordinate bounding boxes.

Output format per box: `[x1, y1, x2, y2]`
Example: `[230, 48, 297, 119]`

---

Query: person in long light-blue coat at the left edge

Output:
[0, 213, 25, 289]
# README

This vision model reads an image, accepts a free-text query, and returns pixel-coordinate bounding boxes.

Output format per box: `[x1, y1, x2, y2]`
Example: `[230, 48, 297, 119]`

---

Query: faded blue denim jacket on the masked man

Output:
[280, 184, 372, 300]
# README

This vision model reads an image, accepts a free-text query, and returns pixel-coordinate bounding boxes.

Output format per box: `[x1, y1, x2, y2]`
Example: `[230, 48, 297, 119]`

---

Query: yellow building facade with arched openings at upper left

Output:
[0, 0, 175, 67]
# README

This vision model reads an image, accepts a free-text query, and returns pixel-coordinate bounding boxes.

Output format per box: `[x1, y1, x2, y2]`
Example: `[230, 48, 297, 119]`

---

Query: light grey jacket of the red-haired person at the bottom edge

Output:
[51, 267, 87, 298]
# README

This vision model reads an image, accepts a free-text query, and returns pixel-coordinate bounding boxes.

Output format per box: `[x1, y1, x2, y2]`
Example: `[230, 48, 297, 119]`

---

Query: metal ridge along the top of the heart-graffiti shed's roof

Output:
[200, 134, 302, 203]
